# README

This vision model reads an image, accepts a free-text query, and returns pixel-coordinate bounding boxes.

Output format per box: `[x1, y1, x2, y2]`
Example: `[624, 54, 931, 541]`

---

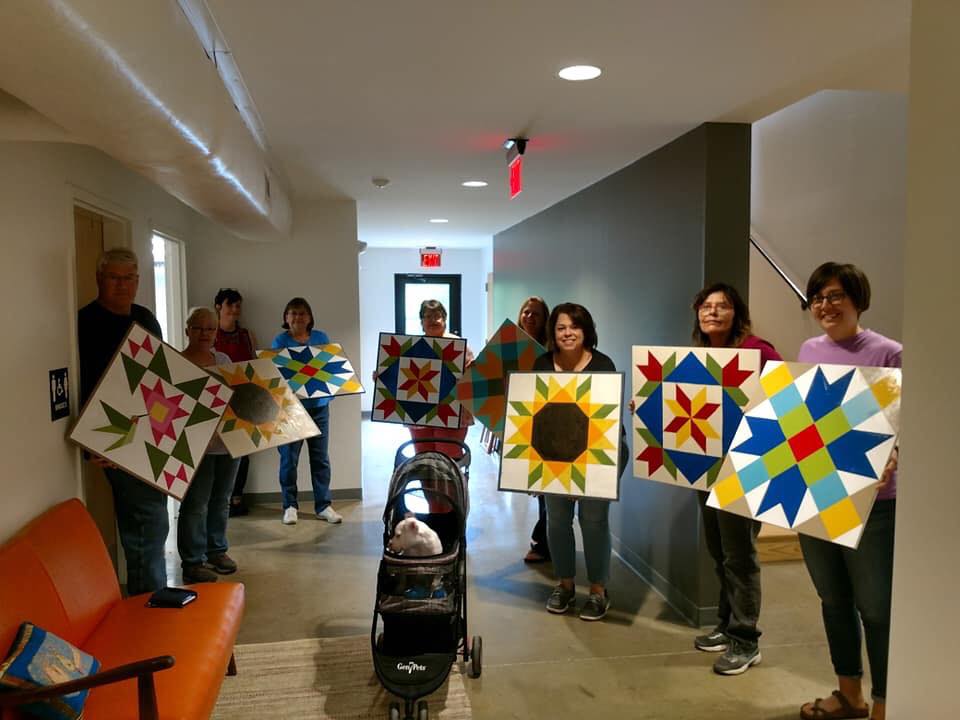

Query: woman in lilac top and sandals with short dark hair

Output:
[798, 262, 903, 720]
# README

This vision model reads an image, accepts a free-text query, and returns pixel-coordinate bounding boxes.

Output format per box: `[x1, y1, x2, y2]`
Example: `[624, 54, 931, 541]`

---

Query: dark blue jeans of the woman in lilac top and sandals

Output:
[800, 500, 897, 701]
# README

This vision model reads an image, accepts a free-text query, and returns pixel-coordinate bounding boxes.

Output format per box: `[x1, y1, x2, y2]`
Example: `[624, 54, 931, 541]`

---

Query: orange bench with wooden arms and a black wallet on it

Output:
[0, 500, 244, 720]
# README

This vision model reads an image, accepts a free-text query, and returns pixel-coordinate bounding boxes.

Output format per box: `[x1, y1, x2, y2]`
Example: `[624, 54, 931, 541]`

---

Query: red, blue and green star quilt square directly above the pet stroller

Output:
[371, 333, 467, 428]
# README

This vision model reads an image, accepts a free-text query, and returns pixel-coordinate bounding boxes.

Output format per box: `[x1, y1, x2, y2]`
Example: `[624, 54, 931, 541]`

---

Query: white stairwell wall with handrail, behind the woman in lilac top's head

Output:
[750, 90, 907, 344]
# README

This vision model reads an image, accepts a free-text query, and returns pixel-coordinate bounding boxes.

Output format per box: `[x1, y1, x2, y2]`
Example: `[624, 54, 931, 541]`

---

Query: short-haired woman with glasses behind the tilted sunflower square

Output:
[177, 308, 240, 583]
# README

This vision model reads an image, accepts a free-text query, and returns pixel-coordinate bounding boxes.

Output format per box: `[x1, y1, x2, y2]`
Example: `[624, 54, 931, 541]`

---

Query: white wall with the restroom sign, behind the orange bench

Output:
[0, 142, 234, 541]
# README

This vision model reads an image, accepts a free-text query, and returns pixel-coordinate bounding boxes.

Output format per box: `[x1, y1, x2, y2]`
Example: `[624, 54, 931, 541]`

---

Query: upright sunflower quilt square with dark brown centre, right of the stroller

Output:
[500, 372, 623, 500]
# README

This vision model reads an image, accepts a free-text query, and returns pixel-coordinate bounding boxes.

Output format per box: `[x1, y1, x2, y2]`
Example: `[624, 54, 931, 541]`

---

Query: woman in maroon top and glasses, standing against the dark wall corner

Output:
[693, 283, 782, 675]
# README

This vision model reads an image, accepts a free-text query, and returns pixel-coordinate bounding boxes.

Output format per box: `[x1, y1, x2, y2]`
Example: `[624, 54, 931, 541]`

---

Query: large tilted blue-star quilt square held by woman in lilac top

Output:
[707, 362, 901, 548]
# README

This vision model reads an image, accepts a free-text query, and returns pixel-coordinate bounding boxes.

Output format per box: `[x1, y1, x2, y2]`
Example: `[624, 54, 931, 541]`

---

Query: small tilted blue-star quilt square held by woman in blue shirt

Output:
[257, 343, 364, 399]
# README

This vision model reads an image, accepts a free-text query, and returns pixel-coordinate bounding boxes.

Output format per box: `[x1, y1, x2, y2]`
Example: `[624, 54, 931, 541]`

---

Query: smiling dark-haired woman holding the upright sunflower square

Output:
[533, 303, 626, 621]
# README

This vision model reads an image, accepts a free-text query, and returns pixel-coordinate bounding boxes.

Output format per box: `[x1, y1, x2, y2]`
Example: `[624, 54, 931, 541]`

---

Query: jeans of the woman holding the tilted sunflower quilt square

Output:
[177, 455, 240, 567]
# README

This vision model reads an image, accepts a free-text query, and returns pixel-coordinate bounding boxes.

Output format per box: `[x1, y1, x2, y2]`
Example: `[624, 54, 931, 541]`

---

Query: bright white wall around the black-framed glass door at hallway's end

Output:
[360, 248, 500, 382]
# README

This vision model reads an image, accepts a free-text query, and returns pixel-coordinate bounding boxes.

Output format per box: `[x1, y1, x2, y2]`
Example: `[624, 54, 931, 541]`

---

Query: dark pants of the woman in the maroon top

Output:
[697, 492, 761, 648]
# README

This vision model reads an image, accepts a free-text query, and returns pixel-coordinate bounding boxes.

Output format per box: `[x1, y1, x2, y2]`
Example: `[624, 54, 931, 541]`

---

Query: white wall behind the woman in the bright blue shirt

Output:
[187, 200, 369, 498]
